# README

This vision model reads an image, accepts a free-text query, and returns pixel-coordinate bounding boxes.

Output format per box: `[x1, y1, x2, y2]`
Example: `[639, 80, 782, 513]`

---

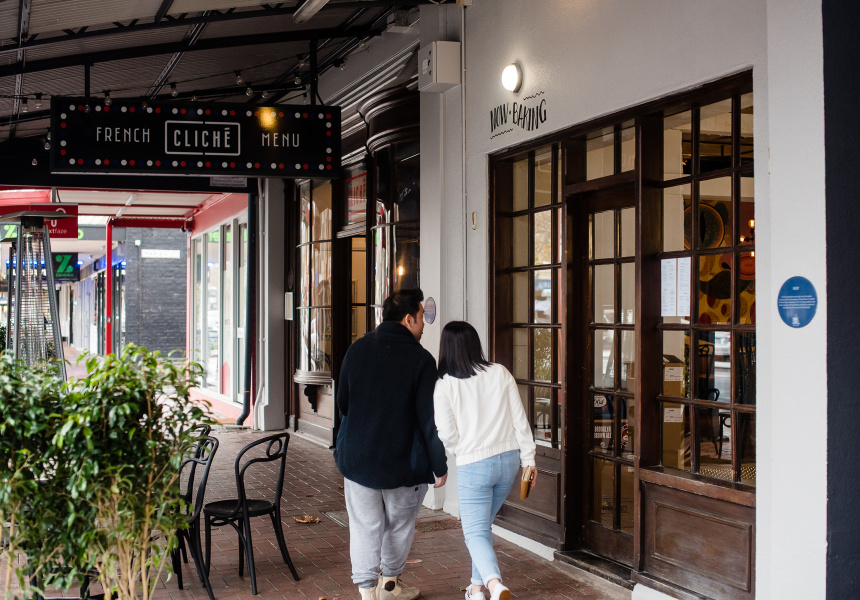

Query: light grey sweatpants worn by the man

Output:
[343, 479, 427, 588]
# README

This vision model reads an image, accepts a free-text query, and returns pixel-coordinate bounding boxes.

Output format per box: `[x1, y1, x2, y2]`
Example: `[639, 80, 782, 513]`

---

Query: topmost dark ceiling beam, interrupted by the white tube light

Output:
[0, 0, 434, 55]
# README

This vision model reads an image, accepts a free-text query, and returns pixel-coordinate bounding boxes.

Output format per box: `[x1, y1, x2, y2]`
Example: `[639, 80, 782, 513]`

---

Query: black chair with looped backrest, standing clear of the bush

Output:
[203, 432, 299, 595]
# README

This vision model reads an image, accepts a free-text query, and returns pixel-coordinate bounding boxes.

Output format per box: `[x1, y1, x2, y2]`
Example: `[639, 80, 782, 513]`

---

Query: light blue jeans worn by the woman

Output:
[457, 450, 520, 585]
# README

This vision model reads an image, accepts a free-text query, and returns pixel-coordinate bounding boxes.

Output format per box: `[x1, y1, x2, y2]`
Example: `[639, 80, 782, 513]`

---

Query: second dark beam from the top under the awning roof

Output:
[0, 27, 374, 77]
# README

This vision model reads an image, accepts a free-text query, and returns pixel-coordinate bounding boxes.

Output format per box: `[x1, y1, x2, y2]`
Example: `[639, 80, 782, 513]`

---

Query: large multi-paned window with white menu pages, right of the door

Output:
[659, 93, 756, 485]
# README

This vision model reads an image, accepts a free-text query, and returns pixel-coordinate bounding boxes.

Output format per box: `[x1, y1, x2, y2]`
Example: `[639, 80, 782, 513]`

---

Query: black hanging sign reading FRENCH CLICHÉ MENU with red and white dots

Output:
[51, 97, 341, 178]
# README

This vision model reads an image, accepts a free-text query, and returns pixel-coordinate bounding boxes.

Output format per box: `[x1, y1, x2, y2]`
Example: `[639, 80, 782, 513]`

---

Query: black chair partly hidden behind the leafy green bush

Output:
[170, 434, 218, 600]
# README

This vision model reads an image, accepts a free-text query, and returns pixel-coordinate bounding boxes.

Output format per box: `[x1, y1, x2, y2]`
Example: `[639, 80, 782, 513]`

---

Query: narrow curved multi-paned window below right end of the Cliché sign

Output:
[297, 181, 333, 373]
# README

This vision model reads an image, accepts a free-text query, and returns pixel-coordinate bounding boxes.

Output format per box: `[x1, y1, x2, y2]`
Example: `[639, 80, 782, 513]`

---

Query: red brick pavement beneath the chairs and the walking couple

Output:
[154, 429, 630, 600]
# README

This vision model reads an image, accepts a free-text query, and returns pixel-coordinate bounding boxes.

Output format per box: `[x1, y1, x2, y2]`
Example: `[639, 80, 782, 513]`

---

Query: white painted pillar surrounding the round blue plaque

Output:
[756, 0, 827, 598]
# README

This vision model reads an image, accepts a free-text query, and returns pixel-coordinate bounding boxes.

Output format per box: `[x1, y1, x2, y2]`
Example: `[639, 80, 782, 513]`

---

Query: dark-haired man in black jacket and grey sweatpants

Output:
[334, 289, 448, 600]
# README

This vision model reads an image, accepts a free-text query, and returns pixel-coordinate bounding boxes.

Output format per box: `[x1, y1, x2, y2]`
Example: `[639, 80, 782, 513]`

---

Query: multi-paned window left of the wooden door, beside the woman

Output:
[493, 146, 563, 448]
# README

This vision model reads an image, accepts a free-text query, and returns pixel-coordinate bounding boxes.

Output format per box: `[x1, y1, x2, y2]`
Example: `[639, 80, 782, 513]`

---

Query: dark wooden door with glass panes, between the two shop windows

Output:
[568, 186, 637, 565]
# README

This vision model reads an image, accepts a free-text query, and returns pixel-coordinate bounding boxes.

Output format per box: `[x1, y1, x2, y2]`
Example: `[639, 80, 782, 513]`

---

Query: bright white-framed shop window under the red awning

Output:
[191, 218, 248, 399]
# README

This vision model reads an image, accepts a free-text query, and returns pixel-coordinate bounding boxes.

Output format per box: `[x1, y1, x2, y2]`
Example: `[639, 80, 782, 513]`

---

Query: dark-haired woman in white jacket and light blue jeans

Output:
[433, 321, 536, 600]
